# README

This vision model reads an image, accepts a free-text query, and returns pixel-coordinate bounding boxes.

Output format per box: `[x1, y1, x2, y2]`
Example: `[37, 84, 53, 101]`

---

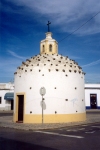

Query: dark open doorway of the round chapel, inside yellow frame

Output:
[18, 95, 24, 122]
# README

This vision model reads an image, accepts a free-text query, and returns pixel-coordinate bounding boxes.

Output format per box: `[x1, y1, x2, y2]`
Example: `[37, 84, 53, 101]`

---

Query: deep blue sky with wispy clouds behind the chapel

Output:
[0, 0, 100, 83]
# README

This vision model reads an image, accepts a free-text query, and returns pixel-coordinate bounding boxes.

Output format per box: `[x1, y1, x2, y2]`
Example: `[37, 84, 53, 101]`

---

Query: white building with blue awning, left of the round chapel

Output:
[0, 82, 14, 110]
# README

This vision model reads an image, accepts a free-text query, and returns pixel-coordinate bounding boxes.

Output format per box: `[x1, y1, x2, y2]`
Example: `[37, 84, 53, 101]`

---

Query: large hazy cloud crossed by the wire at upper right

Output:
[9, 0, 100, 35]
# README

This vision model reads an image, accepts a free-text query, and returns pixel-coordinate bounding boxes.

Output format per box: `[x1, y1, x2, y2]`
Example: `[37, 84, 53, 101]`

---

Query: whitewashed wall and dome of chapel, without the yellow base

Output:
[15, 55, 85, 114]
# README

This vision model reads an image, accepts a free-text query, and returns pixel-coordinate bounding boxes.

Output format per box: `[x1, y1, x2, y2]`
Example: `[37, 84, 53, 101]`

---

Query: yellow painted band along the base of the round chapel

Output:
[24, 113, 86, 123]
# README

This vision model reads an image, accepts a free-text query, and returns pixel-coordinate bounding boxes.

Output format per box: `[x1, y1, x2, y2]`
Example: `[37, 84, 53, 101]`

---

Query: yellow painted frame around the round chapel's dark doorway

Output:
[13, 92, 26, 123]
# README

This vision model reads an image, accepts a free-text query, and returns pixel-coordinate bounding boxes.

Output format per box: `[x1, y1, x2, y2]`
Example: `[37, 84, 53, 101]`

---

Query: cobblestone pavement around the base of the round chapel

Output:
[0, 110, 100, 130]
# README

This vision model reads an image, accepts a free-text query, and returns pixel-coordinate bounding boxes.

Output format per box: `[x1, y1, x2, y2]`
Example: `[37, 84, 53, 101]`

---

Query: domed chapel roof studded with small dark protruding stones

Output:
[14, 54, 84, 75]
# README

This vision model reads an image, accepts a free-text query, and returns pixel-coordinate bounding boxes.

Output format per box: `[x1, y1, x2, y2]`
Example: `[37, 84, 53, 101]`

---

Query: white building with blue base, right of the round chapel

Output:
[85, 84, 100, 109]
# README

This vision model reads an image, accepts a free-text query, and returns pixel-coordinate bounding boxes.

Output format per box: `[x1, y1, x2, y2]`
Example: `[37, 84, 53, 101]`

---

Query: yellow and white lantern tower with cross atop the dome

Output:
[40, 21, 58, 54]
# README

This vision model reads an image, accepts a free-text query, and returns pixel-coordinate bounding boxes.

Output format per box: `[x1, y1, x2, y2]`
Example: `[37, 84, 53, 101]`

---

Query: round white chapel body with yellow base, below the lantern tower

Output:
[14, 54, 86, 123]
